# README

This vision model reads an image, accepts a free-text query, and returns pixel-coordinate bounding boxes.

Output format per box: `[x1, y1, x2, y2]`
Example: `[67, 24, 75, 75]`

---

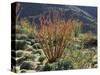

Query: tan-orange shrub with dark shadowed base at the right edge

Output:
[79, 32, 97, 48]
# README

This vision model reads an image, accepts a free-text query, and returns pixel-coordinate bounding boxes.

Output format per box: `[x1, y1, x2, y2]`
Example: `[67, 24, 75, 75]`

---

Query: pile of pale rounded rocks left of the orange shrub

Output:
[12, 34, 45, 73]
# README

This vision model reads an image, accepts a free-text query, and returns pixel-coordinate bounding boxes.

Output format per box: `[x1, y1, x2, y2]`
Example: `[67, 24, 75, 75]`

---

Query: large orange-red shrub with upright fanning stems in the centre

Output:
[37, 20, 75, 62]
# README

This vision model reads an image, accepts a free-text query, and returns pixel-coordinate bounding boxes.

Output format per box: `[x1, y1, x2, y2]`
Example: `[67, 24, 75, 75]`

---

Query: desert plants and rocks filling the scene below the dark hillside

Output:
[11, 2, 97, 72]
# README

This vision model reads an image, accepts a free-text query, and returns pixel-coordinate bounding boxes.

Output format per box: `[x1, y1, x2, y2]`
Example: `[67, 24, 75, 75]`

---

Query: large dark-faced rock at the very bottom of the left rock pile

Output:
[20, 61, 36, 70]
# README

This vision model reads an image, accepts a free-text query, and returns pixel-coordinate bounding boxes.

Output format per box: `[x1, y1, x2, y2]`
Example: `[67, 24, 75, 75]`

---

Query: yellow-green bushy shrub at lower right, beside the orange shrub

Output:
[64, 49, 97, 69]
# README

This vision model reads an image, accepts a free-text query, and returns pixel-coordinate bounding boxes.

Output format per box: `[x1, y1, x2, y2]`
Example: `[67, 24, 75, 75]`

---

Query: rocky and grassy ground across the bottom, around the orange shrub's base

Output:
[12, 33, 97, 73]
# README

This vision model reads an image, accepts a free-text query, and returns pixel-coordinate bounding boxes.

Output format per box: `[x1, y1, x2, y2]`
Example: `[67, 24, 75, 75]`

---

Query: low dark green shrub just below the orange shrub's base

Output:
[43, 60, 73, 71]
